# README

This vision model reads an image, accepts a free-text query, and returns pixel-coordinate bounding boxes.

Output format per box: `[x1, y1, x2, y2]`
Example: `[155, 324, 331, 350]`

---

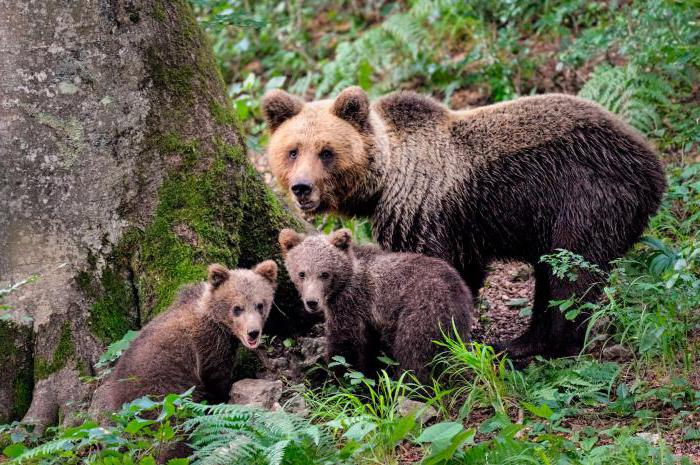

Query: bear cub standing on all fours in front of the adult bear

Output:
[279, 229, 472, 382]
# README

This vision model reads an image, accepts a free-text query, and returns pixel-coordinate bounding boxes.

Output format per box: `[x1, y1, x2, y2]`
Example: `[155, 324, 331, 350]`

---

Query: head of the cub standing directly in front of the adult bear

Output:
[279, 229, 353, 313]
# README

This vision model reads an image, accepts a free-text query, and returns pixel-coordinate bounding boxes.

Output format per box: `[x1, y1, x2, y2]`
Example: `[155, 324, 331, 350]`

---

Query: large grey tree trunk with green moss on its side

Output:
[0, 0, 306, 425]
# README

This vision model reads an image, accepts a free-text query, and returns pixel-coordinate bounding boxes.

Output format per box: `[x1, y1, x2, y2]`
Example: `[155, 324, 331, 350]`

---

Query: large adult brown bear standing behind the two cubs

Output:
[263, 87, 665, 357]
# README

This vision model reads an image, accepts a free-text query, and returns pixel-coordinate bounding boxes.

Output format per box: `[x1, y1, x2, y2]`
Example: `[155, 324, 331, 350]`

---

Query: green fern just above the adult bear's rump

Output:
[578, 65, 673, 134]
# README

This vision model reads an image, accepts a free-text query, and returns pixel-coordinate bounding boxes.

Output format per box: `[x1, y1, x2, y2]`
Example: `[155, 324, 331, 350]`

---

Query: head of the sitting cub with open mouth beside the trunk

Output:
[205, 260, 277, 349]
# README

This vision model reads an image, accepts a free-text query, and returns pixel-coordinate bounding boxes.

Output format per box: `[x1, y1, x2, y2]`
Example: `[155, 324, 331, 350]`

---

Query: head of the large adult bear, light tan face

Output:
[262, 87, 371, 212]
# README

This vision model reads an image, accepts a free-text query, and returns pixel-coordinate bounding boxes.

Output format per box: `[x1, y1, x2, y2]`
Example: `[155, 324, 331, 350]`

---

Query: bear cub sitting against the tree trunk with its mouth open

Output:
[90, 260, 277, 414]
